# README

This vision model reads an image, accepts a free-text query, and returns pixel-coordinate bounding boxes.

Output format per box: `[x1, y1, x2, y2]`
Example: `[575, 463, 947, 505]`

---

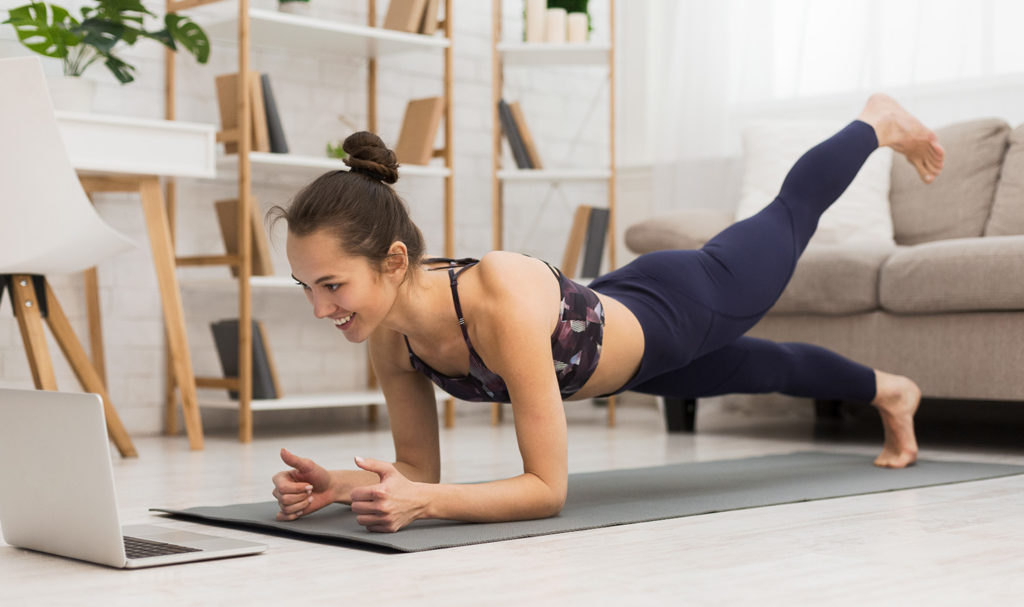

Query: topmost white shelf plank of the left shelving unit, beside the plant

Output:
[196, 3, 451, 59]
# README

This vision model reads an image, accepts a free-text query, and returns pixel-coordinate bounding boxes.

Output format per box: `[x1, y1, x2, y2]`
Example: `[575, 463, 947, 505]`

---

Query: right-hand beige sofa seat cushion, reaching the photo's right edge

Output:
[879, 236, 1024, 314]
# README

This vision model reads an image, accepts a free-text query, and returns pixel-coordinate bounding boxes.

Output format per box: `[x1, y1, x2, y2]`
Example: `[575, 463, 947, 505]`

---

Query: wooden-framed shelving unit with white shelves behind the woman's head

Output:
[165, 0, 455, 442]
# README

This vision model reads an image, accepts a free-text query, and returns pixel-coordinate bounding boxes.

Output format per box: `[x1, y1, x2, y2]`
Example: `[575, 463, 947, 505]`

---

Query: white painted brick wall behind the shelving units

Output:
[0, 0, 624, 434]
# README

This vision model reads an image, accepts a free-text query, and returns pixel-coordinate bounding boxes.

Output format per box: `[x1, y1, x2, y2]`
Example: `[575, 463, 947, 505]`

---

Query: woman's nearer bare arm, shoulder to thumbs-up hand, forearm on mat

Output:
[352, 255, 568, 531]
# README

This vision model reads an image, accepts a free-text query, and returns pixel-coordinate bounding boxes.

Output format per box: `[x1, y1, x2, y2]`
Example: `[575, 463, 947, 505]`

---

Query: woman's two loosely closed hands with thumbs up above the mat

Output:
[273, 449, 425, 532]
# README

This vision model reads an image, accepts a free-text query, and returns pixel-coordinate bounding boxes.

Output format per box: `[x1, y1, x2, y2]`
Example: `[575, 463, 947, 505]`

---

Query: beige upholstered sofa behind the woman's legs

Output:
[626, 119, 1024, 430]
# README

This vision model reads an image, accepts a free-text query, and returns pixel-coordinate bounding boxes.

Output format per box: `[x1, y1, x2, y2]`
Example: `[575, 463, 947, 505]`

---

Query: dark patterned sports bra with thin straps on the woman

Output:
[402, 258, 604, 402]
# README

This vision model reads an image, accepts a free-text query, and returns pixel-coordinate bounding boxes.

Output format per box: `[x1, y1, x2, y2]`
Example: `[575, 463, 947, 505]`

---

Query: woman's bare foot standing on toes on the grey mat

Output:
[871, 371, 921, 468]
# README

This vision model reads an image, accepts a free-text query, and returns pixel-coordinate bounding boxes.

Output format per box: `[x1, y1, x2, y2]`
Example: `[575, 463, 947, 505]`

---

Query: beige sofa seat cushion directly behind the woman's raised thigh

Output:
[771, 245, 895, 315]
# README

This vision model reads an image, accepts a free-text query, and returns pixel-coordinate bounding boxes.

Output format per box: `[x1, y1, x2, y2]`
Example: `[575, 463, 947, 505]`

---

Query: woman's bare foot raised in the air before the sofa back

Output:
[857, 93, 946, 183]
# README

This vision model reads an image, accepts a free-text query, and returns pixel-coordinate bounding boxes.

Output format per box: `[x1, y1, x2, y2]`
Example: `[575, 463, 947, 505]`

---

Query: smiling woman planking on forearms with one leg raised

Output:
[271, 95, 944, 531]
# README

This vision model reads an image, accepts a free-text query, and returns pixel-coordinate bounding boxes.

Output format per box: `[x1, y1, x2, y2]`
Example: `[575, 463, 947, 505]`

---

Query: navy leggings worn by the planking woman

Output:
[590, 121, 878, 402]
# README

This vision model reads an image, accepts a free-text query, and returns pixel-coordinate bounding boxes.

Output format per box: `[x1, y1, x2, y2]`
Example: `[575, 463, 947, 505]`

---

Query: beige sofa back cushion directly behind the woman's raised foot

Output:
[889, 119, 1010, 245]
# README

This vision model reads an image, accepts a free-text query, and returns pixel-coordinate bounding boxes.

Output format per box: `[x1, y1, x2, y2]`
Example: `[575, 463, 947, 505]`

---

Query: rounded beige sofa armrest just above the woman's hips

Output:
[626, 209, 736, 255]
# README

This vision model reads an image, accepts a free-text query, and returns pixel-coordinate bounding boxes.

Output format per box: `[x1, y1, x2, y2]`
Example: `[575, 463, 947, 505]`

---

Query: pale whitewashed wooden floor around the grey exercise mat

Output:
[6, 397, 1024, 607]
